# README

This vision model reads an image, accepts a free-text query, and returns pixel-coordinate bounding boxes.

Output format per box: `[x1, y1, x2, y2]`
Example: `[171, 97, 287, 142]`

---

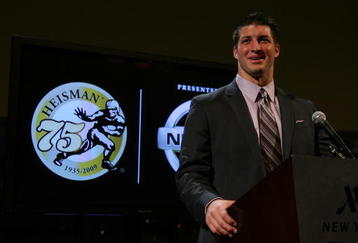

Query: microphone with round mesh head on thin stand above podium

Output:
[312, 111, 354, 159]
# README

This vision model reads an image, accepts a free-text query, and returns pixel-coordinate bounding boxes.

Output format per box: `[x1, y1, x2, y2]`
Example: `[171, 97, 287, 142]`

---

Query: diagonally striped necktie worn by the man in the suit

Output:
[257, 88, 282, 174]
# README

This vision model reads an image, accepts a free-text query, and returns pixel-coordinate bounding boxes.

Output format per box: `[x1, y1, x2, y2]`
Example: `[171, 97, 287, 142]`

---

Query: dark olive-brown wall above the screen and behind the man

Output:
[0, 0, 358, 130]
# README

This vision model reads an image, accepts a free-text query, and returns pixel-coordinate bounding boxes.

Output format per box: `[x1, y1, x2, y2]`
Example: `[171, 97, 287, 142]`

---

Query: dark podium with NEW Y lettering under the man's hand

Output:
[216, 156, 358, 243]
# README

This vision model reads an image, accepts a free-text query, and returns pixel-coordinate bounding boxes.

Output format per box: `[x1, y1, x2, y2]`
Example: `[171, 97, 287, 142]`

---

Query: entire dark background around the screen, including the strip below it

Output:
[0, 0, 358, 242]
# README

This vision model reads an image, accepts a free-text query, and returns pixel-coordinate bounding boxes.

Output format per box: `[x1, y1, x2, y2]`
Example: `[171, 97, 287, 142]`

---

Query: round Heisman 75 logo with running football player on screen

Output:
[31, 82, 127, 181]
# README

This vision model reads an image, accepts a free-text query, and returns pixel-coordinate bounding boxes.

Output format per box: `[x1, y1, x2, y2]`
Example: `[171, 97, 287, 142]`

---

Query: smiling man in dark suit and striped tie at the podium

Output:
[176, 13, 329, 243]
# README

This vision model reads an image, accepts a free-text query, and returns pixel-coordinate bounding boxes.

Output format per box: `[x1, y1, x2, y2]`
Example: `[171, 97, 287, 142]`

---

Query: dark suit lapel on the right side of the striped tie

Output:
[276, 88, 294, 160]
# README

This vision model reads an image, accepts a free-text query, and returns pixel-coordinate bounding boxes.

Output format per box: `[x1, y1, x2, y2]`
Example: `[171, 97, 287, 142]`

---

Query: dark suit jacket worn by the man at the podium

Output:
[176, 81, 329, 243]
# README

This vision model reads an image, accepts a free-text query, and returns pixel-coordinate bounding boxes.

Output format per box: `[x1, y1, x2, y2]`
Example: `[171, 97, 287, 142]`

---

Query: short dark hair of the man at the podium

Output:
[232, 12, 279, 47]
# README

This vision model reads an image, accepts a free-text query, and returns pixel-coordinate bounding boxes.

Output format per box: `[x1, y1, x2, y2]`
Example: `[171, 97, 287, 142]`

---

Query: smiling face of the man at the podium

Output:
[233, 25, 280, 80]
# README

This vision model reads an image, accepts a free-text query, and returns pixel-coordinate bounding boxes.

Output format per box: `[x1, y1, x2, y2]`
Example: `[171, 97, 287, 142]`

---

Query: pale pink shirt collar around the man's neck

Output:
[236, 74, 275, 103]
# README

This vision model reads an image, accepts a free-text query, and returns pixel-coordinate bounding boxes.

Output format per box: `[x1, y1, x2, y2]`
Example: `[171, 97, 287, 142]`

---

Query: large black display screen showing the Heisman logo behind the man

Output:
[5, 38, 235, 213]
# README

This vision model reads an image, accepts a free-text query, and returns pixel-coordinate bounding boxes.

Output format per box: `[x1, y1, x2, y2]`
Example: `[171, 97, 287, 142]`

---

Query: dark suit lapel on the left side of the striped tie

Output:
[226, 80, 262, 161]
